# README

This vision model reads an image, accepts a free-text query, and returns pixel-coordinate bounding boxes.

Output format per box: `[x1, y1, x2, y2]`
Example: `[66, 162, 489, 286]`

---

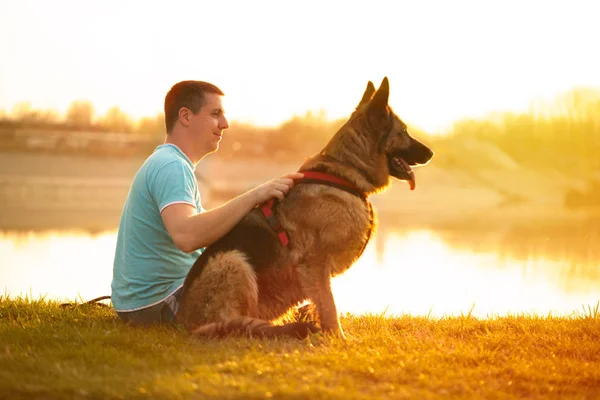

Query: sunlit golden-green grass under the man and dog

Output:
[0, 297, 600, 399]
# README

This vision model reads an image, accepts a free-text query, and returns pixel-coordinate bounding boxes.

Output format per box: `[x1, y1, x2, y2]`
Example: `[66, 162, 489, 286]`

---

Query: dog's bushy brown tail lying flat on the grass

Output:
[191, 317, 319, 339]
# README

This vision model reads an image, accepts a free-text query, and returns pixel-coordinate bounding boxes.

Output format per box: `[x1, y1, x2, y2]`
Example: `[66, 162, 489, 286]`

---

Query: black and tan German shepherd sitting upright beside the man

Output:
[176, 77, 433, 337]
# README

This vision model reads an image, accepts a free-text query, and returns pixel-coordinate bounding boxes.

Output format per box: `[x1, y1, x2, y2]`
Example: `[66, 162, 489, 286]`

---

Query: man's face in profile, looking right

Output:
[189, 93, 229, 154]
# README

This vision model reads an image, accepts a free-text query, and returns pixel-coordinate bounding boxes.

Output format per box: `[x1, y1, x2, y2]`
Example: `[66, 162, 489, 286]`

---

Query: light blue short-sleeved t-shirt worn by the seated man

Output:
[111, 144, 203, 312]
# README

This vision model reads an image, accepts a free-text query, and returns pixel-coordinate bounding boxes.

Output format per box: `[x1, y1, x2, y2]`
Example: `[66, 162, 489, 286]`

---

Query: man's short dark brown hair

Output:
[165, 81, 224, 133]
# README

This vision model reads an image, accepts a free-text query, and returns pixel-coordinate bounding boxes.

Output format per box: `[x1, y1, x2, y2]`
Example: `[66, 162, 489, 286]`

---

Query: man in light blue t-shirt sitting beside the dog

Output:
[111, 81, 302, 325]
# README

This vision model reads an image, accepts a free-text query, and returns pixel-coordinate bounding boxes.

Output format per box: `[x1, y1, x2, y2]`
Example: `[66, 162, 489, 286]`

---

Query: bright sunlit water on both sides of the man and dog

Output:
[0, 230, 600, 317]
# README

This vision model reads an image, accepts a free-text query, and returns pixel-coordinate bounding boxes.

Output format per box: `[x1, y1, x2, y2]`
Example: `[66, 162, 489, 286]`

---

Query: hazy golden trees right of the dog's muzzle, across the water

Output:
[439, 88, 600, 174]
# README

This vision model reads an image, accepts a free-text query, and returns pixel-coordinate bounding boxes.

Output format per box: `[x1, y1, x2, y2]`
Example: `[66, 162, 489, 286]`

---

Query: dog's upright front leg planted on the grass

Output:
[299, 262, 345, 339]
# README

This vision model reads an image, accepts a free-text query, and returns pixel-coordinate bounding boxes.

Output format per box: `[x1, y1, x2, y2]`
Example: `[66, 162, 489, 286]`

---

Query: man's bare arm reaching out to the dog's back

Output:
[161, 173, 303, 253]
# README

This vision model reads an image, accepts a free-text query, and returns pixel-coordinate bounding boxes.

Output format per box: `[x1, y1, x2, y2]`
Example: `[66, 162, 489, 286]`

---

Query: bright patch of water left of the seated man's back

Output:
[0, 232, 116, 301]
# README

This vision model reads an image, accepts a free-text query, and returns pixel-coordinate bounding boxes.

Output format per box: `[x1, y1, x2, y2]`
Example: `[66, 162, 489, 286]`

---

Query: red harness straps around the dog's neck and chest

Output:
[260, 171, 366, 246]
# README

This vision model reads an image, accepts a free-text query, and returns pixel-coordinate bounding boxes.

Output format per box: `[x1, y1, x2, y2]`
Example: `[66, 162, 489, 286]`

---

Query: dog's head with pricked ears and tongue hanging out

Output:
[353, 77, 434, 190]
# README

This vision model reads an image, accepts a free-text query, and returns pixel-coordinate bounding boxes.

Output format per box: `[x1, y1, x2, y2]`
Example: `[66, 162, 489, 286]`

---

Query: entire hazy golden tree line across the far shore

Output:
[0, 88, 600, 172]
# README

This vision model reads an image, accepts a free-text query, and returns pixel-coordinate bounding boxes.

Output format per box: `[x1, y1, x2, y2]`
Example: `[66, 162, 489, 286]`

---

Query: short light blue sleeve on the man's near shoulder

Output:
[149, 162, 196, 213]
